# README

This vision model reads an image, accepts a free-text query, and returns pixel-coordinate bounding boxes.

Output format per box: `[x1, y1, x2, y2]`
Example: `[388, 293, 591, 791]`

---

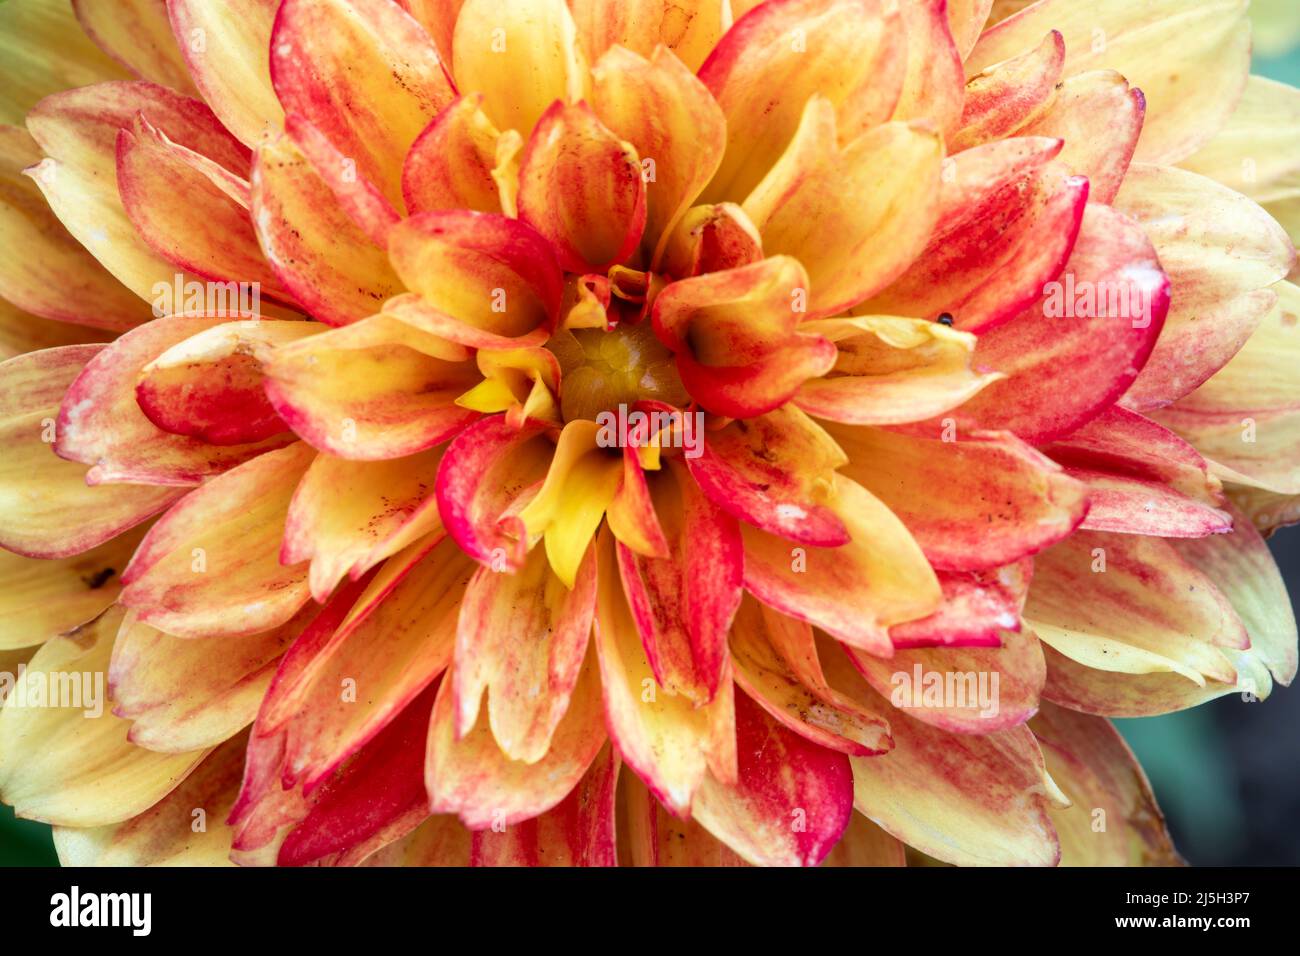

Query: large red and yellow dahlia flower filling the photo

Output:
[0, 0, 1300, 865]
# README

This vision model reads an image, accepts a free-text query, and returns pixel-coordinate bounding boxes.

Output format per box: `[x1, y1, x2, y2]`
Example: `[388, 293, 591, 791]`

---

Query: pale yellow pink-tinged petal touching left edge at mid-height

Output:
[0, 345, 181, 561]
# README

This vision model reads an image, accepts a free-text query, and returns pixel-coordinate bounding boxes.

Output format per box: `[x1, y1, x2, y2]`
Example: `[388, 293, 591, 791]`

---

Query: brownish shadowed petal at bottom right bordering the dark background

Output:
[1030, 704, 1182, 866]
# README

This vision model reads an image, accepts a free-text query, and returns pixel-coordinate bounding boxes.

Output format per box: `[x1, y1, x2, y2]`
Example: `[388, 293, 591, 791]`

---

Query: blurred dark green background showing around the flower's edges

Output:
[0, 0, 1300, 866]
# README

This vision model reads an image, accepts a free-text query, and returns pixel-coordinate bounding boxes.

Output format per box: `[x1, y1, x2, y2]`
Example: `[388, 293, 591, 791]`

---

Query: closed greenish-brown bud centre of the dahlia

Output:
[546, 319, 690, 421]
